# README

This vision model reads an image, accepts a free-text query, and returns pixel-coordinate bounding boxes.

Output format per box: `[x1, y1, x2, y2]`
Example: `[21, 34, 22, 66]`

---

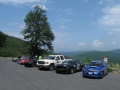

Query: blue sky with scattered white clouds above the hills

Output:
[0, 0, 120, 52]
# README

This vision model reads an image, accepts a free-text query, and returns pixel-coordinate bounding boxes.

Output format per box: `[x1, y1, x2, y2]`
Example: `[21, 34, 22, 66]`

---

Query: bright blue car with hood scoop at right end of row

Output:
[83, 60, 108, 78]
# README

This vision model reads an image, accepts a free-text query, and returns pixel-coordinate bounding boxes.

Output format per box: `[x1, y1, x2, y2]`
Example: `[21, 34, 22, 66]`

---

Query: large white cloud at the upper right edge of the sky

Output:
[98, 5, 120, 31]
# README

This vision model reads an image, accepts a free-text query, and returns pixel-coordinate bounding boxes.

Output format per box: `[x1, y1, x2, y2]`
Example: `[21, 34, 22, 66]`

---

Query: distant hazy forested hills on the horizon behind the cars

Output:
[61, 49, 120, 63]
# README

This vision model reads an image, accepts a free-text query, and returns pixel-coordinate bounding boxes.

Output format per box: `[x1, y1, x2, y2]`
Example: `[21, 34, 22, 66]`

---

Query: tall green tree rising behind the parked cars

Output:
[21, 6, 55, 55]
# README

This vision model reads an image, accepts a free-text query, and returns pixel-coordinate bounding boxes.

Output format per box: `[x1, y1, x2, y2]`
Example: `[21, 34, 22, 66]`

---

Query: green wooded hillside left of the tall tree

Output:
[0, 35, 28, 57]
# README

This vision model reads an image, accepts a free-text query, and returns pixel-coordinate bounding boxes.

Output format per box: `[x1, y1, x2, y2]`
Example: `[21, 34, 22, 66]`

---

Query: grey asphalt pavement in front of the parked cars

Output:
[0, 58, 120, 90]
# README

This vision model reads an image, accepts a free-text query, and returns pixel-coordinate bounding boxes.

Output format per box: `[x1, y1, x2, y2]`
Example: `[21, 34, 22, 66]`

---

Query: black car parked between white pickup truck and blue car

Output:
[56, 60, 84, 74]
